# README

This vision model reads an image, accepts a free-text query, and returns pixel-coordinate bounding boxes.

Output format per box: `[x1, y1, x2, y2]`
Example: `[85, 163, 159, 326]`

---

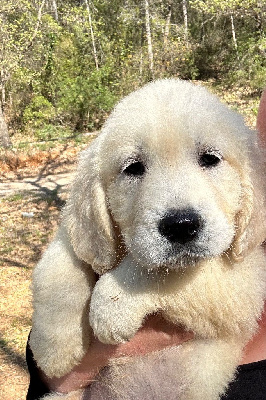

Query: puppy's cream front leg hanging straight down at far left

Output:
[30, 227, 94, 377]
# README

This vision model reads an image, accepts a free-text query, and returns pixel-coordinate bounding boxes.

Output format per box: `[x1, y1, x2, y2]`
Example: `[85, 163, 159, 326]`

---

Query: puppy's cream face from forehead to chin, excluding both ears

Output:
[99, 81, 247, 268]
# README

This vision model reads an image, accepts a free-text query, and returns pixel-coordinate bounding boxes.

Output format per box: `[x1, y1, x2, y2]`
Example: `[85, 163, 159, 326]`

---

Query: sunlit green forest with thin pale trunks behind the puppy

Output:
[0, 0, 266, 146]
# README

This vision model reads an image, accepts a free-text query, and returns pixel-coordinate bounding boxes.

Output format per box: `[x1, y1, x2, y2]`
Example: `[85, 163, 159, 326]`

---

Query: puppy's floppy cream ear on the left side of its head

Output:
[62, 139, 116, 274]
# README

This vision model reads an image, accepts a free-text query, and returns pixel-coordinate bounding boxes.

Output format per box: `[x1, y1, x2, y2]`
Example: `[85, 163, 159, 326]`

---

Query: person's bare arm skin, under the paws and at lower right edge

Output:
[30, 307, 266, 400]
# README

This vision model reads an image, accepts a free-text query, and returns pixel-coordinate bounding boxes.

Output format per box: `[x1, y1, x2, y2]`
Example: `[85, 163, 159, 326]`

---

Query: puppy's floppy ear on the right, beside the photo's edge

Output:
[232, 145, 266, 261]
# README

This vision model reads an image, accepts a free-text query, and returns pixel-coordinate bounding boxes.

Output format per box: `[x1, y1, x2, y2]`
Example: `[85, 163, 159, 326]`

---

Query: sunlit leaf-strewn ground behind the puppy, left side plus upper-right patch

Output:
[0, 84, 259, 400]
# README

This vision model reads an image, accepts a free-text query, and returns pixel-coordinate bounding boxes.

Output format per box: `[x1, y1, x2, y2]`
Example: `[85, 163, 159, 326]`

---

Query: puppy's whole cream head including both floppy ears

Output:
[64, 80, 265, 274]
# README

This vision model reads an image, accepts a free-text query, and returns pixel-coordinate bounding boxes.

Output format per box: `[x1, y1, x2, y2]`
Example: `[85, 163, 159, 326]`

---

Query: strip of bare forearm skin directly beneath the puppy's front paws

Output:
[42, 315, 193, 393]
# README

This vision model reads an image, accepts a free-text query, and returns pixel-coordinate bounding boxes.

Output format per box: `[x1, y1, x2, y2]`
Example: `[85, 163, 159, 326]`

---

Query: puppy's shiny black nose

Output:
[158, 210, 202, 244]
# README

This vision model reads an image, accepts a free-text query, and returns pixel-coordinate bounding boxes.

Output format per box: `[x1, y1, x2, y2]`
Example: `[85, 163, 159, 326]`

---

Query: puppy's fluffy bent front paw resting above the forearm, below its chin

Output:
[90, 256, 159, 344]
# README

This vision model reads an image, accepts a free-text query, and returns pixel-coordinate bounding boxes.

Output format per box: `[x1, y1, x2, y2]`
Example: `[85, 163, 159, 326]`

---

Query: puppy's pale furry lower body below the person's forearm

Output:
[77, 339, 241, 400]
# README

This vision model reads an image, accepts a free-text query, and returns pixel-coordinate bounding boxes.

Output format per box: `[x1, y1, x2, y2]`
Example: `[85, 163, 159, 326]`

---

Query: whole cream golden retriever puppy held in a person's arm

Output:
[30, 79, 266, 400]
